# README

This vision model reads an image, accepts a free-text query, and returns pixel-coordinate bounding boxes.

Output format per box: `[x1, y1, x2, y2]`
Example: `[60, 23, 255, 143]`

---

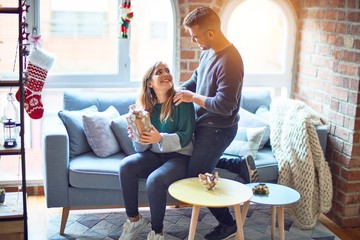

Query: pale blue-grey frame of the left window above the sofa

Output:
[27, 0, 180, 88]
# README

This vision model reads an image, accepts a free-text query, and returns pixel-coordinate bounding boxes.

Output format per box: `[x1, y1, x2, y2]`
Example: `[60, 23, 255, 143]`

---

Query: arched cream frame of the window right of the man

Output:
[221, 0, 297, 96]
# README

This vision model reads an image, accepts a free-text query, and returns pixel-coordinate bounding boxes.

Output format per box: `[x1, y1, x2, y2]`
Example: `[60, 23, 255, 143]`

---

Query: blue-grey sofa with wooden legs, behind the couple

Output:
[42, 91, 327, 234]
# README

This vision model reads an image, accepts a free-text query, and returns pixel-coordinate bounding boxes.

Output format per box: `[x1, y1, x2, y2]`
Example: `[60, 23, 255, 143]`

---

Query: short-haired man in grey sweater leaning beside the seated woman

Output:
[174, 7, 256, 240]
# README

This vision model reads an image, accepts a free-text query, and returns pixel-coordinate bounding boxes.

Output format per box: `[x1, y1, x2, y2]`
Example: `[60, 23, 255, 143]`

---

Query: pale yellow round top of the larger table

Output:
[169, 177, 253, 207]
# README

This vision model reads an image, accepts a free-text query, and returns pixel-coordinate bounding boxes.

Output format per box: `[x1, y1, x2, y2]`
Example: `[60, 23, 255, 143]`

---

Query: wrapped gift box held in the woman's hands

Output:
[126, 104, 151, 142]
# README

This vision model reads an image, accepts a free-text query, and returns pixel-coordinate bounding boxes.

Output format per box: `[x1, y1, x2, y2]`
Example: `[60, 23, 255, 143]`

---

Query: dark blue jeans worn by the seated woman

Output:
[120, 150, 190, 233]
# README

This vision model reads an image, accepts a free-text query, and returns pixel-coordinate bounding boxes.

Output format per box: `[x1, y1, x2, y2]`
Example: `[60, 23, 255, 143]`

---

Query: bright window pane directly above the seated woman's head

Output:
[130, 0, 178, 82]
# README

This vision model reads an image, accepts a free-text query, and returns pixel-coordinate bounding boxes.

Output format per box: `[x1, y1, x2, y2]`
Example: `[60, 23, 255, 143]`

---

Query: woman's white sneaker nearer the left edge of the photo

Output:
[119, 215, 149, 240]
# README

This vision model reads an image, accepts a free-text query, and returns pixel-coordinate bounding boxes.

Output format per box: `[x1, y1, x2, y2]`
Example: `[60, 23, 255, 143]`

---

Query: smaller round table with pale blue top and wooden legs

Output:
[246, 183, 300, 240]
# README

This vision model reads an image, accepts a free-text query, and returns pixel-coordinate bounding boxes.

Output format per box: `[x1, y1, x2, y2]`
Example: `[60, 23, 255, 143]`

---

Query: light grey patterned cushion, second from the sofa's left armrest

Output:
[82, 106, 121, 158]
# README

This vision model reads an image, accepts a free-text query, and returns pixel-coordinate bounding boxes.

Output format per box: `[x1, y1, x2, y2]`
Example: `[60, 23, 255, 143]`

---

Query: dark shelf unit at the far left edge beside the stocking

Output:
[0, 0, 28, 240]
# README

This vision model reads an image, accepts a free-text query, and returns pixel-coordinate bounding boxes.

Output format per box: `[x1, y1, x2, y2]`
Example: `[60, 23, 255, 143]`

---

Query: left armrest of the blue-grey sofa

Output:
[42, 112, 70, 207]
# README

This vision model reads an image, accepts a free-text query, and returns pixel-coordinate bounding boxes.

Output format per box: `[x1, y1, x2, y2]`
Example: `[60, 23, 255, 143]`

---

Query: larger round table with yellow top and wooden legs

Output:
[169, 177, 253, 240]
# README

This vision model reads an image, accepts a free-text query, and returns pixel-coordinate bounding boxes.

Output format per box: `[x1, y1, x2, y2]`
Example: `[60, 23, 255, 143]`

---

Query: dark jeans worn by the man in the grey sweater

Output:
[188, 124, 238, 225]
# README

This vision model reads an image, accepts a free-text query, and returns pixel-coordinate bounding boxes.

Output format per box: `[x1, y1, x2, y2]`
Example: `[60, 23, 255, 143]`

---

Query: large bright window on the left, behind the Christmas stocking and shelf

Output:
[0, 0, 179, 184]
